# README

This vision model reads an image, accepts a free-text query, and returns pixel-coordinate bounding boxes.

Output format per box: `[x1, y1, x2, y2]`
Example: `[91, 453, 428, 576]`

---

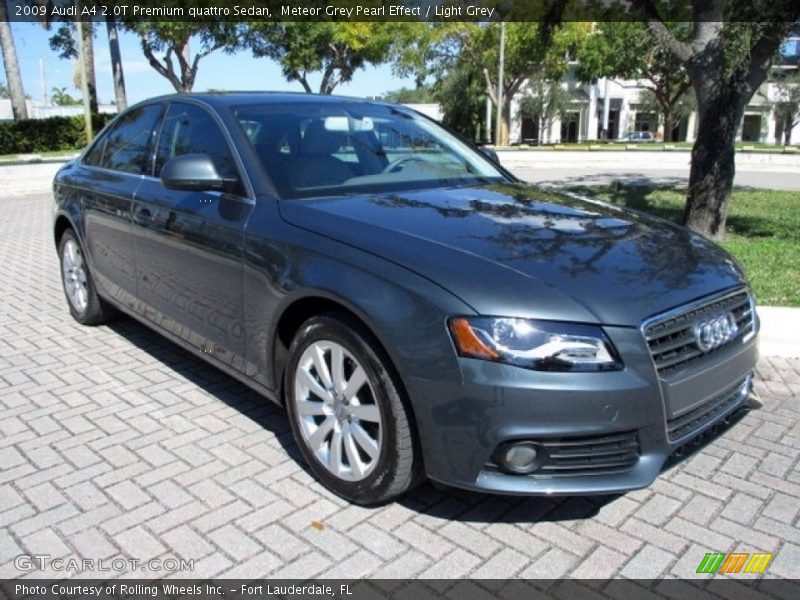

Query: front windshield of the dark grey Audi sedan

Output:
[233, 102, 506, 198]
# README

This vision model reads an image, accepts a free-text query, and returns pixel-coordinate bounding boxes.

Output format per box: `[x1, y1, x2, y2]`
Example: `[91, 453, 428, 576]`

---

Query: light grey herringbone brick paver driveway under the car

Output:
[0, 186, 800, 578]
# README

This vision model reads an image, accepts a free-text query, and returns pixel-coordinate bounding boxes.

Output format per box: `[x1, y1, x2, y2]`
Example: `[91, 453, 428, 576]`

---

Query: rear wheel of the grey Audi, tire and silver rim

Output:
[58, 229, 115, 325]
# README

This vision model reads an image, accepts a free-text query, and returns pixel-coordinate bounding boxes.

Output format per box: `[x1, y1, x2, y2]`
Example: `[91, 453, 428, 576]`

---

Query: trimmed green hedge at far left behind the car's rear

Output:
[0, 113, 116, 155]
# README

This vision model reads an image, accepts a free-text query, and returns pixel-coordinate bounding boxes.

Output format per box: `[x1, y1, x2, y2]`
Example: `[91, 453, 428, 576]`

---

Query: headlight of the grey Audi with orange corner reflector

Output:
[449, 317, 622, 371]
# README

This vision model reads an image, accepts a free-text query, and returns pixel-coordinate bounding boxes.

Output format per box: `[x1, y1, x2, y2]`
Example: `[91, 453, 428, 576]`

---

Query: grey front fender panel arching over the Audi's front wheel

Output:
[244, 203, 474, 389]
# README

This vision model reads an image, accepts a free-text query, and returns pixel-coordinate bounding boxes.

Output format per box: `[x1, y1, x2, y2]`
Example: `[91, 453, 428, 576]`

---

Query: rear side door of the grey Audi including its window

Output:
[78, 104, 164, 307]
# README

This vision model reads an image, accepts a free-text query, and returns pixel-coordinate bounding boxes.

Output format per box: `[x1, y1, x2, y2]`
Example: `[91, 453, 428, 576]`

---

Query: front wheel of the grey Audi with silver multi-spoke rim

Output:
[284, 314, 422, 505]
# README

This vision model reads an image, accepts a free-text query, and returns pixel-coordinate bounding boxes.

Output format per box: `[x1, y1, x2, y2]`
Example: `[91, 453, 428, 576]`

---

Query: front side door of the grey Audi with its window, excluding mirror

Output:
[133, 102, 253, 370]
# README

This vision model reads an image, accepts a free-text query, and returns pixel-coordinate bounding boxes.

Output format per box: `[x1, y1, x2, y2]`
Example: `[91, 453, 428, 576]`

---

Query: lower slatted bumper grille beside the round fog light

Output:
[484, 431, 639, 479]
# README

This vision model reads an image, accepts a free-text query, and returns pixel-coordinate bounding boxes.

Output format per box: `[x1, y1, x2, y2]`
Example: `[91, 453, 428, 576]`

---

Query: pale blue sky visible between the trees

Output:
[6, 23, 414, 104]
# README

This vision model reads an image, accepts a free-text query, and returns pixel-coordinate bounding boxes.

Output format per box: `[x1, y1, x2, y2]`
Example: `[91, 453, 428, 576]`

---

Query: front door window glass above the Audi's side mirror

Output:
[156, 102, 239, 179]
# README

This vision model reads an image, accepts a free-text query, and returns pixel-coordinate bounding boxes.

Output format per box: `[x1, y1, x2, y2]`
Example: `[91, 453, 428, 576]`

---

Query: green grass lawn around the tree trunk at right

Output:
[570, 186, 800, 307]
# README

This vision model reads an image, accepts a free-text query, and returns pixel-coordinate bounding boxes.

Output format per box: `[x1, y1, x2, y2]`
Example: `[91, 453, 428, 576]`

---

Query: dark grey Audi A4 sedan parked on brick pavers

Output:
[54, 93, 758, 504]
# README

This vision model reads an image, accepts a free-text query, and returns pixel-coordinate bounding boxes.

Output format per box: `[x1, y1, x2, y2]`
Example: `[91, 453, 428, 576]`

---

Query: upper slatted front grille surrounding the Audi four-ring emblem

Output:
[644, 290, 754, 375]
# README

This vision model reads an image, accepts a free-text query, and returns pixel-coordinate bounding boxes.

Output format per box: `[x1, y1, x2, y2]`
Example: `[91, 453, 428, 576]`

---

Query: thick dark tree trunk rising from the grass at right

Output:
[684, 84, 752, 240]
